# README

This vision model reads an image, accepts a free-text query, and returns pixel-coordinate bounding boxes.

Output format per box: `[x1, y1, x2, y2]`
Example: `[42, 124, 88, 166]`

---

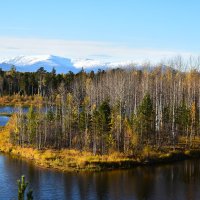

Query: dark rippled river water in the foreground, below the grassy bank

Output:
[0, 155, 200, 200]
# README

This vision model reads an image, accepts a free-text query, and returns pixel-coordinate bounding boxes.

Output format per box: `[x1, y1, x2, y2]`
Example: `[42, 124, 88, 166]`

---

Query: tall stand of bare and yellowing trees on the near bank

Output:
[6, 59, 200, 154]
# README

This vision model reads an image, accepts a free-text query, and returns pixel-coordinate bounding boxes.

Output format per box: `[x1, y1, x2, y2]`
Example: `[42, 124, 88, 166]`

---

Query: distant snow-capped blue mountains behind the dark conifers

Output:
[0, 55, 135, 73]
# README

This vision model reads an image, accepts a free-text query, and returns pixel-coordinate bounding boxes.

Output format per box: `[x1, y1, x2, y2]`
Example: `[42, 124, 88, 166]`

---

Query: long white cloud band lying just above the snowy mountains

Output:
[0, 37, 198, 64]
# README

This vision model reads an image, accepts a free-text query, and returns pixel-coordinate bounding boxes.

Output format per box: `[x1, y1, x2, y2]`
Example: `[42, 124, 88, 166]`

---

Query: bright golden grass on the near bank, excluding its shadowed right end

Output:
[0, 122, 137, 171]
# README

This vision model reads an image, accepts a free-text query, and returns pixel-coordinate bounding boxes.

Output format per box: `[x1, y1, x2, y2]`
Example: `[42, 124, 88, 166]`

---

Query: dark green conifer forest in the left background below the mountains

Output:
[0, 66, 75, 96]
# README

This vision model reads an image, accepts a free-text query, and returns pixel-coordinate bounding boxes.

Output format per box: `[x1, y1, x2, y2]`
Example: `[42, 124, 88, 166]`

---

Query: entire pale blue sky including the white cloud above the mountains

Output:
[0, 0, 200, 60]
